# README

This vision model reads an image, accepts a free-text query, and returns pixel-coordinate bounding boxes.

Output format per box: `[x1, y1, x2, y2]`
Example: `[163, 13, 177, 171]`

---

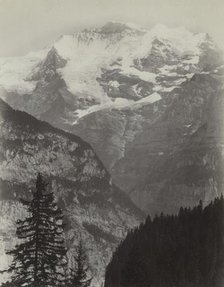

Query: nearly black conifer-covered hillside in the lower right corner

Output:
[105, 197, 224, 287]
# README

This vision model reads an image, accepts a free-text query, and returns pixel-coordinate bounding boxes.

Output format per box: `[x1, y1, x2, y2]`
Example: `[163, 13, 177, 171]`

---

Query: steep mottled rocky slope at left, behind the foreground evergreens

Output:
[0, 100, 143, 284]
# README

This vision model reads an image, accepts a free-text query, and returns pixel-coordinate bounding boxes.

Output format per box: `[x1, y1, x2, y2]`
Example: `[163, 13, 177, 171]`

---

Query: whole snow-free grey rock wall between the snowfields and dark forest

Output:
[74, 73, 224, 214]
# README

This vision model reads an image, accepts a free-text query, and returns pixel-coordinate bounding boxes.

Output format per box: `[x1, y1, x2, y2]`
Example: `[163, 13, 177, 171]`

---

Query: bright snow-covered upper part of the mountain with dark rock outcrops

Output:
[0, 22, 220, 115]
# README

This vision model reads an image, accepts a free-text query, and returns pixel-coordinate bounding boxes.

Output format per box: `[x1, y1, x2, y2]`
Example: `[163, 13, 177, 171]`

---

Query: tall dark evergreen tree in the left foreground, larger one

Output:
[4, 174, 66, 287]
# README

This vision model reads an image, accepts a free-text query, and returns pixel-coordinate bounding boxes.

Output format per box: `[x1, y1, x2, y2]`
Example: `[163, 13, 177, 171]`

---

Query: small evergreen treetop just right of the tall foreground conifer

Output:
[69, 240, 92, 287]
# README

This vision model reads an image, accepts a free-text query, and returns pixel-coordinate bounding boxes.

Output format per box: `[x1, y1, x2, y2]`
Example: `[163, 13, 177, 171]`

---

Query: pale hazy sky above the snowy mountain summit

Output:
[0, 0, 224, 56]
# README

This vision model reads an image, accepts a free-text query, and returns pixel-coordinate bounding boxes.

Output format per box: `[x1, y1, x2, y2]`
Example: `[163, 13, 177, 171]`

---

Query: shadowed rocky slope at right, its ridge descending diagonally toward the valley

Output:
[121, 74, 224, 214]
